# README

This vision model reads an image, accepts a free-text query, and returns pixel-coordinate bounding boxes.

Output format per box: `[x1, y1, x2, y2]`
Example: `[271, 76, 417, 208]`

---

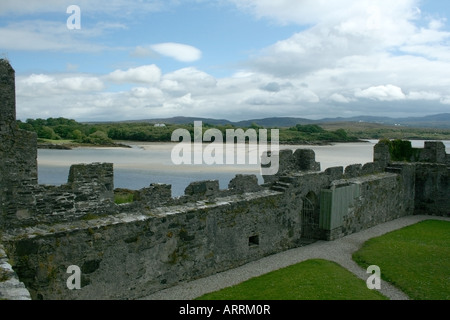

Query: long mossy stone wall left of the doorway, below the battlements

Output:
[4, 190, 301, 299]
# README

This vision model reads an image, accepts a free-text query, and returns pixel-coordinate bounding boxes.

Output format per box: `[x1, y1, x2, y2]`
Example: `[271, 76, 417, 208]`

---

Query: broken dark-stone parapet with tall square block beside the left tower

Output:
[1, 163, 117, 229]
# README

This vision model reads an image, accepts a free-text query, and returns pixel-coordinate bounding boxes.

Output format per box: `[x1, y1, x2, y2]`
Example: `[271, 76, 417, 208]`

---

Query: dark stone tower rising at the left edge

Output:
[0, 59, 37, 229]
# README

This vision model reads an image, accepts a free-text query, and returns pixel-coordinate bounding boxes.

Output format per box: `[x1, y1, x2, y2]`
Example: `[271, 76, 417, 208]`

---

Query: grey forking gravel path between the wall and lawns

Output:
[143, 216, 450, 300]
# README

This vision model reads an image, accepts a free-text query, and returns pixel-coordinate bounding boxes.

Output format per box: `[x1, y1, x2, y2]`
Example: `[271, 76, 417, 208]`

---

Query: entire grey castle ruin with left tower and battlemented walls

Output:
[0, 60, 450, 299]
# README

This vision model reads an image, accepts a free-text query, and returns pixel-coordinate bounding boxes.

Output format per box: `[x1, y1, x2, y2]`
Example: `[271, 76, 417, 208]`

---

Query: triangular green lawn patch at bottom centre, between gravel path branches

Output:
[198, 259, 386, 300]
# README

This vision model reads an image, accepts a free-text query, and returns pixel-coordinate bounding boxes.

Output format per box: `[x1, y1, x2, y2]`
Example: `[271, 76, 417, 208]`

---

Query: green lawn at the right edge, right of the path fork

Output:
[353, 220, 450, 300]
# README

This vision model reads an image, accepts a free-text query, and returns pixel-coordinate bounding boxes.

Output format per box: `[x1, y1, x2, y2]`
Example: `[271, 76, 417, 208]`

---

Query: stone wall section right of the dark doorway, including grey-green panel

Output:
[321, 169, 414, 240]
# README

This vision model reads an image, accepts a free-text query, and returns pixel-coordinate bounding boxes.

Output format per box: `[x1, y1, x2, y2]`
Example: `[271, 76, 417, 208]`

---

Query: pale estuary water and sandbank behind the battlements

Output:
[38, 140, 450, 197]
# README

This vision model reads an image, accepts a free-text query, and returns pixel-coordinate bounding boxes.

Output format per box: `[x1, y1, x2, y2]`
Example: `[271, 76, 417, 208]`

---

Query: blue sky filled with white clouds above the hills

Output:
[0, 0, 450, 121]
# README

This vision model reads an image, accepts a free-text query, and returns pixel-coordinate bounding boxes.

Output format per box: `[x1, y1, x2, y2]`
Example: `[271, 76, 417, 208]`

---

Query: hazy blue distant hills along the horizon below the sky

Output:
[127, 113, 450, 129]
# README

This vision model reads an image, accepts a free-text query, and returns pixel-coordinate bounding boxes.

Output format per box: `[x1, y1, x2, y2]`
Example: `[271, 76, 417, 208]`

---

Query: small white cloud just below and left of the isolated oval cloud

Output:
[106, 64, 161, 83]
